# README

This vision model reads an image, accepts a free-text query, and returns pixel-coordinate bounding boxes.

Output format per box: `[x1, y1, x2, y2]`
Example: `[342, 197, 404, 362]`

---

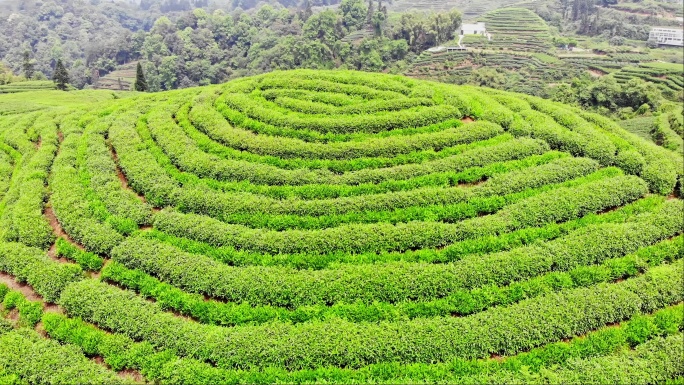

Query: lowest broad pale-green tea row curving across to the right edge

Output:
[60, 266, 684, 370]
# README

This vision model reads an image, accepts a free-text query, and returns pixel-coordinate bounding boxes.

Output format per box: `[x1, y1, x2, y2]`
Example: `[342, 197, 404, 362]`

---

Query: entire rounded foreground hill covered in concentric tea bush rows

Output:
[0, 70, 684, 384]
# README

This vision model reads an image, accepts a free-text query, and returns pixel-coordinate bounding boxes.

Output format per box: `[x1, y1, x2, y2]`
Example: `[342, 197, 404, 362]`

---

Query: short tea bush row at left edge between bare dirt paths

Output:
[0, 242, 83, 302]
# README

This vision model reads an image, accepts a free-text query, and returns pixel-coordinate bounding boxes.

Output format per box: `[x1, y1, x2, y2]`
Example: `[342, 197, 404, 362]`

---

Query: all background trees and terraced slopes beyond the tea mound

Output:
[0, 0, 684, 142]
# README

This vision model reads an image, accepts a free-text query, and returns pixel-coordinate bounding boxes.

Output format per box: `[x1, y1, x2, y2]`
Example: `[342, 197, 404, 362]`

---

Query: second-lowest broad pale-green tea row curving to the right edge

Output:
[112, 204, 682, 308]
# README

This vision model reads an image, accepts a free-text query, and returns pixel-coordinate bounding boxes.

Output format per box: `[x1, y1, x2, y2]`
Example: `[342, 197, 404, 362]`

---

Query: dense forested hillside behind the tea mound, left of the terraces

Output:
[0, 0, 461, 91]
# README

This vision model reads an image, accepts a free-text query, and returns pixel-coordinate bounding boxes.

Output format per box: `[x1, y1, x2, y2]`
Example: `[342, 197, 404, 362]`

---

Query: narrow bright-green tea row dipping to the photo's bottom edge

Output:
[43, 304, 682, 384]
